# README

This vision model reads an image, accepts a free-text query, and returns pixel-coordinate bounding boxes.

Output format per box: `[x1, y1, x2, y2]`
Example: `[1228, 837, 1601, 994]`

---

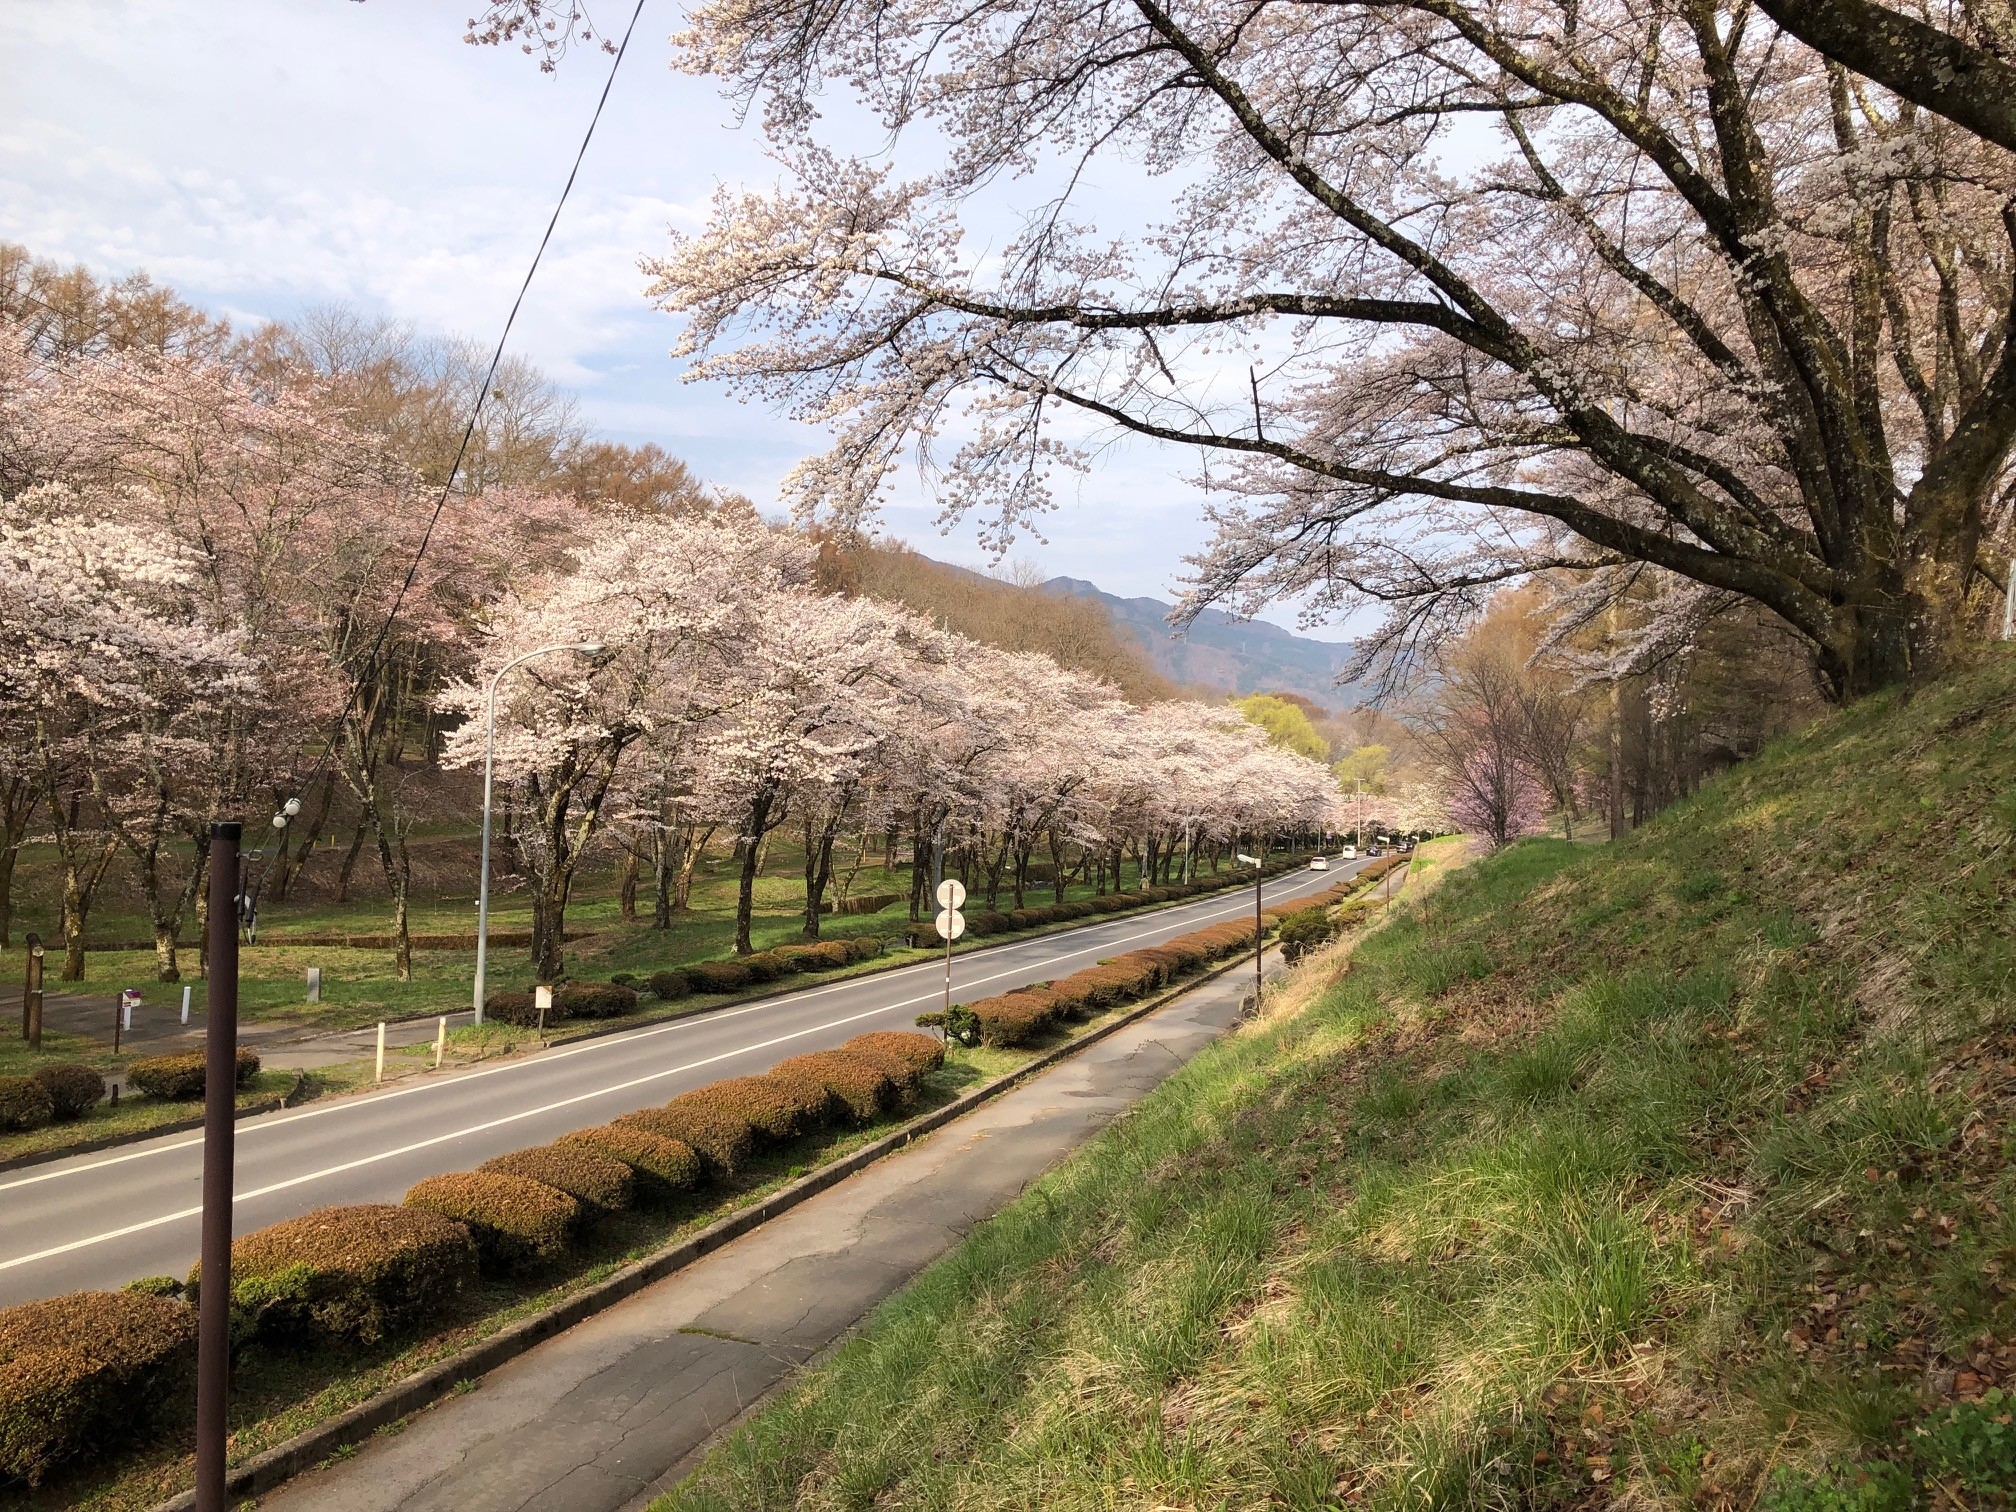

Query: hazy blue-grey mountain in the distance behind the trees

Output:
[1042, 577, 1359, 710]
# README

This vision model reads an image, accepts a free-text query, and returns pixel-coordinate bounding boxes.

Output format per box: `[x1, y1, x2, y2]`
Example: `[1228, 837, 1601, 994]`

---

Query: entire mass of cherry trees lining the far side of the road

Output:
[0, 321, 1335, 980]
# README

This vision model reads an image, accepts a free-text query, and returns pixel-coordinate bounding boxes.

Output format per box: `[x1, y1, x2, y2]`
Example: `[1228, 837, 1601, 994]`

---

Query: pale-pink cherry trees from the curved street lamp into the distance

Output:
[444, 512, 1341, 974]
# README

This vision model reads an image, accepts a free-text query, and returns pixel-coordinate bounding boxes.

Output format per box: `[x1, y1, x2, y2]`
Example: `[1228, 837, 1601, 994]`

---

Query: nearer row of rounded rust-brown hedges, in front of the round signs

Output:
[0, 1032, 946, 1486]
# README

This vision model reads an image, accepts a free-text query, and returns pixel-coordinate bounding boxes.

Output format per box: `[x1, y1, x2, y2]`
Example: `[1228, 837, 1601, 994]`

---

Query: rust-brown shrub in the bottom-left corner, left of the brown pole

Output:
[0, 1292, 196, 1486]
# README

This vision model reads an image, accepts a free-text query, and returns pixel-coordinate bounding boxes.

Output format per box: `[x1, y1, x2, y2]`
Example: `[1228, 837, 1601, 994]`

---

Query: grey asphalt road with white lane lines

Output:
[0, 861, 1365, 1304]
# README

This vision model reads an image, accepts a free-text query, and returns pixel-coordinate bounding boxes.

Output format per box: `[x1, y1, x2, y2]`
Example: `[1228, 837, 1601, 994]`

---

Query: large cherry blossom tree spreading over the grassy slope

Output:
[620, 0, 2016, 698]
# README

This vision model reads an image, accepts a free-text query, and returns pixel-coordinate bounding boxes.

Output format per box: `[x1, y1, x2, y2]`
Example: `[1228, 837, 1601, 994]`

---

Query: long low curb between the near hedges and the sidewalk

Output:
[149, 948, 1280, 1512]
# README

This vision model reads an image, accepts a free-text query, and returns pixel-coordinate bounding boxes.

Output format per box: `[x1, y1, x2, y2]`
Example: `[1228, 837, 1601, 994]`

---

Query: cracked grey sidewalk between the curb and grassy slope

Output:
[260, 972, 1252, 1512]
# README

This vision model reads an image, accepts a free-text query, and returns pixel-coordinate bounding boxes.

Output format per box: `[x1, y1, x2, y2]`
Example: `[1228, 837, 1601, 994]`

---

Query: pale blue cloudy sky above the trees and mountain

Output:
[0, 0, 1341, 639]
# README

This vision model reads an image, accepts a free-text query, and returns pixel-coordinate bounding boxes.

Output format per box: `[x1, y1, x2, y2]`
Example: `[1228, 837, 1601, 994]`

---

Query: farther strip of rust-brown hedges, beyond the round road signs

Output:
[939, 857, 1399, 1044]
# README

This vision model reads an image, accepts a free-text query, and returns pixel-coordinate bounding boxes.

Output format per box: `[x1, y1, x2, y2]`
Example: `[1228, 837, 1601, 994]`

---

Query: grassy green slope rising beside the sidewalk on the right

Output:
[661, 655, 2016, 1512]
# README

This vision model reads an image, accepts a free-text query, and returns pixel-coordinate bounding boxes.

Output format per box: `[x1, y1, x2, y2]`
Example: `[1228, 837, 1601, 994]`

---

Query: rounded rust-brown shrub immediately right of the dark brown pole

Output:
[185, 1202, 476, 1345]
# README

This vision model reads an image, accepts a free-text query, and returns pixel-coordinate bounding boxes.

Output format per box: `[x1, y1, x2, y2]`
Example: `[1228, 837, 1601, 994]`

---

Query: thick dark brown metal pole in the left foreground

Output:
[196, 825, 240, 1512]
